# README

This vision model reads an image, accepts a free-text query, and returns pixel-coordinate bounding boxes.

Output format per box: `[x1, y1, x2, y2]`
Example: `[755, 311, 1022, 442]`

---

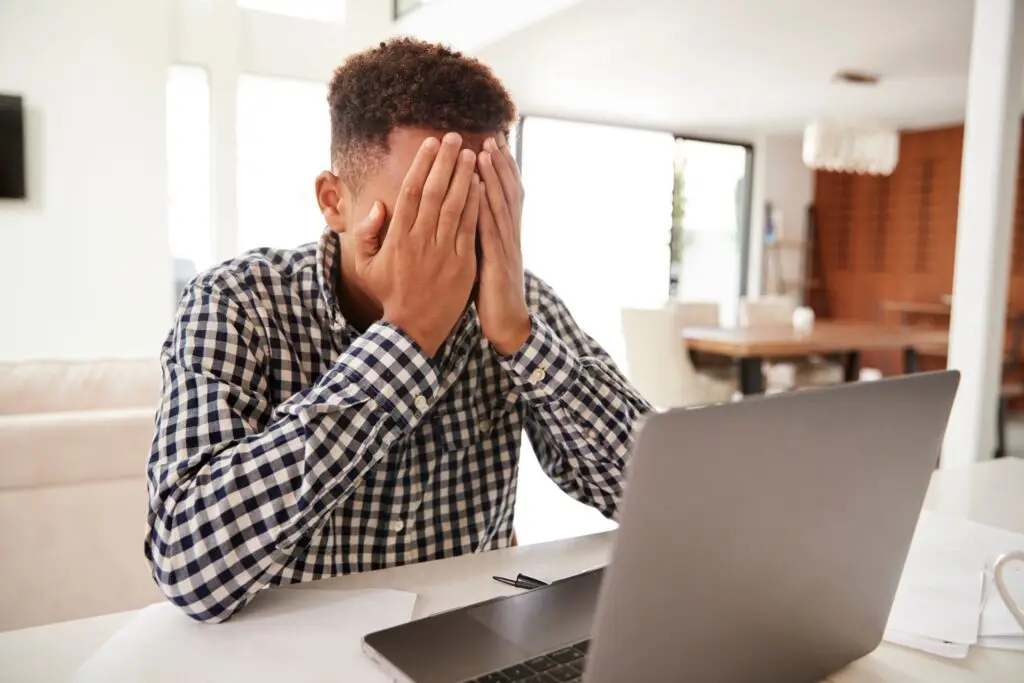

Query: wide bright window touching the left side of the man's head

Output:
[238, 75, 331, 251]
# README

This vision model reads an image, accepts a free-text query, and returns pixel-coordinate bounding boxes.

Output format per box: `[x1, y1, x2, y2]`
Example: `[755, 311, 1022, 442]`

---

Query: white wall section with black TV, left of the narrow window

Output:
[0, 0, 171, 359]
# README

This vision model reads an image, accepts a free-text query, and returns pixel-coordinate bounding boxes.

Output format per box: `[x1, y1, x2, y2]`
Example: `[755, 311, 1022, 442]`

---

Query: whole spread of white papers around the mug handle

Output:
[885, 510, 1024, 657]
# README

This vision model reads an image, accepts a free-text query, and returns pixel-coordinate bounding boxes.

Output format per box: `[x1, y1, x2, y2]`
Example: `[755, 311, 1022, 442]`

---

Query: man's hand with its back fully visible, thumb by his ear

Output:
[355, 133, 481, 355]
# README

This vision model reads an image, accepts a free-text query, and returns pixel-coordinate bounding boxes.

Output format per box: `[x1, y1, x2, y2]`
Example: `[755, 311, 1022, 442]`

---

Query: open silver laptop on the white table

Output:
[364, 372, 959, 683]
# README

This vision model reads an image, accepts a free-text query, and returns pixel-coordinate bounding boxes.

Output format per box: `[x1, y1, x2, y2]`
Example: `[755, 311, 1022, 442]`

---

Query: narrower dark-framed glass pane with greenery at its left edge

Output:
[672, 138, 751, 321]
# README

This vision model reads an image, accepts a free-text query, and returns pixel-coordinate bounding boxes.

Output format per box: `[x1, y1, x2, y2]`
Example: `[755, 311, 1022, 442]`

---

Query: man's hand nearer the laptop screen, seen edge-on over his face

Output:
[476, 136, 530, 355]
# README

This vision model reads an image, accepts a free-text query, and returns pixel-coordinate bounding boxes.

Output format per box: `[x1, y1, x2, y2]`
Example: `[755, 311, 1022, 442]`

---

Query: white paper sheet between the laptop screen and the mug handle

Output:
[884, 541, 984, 651]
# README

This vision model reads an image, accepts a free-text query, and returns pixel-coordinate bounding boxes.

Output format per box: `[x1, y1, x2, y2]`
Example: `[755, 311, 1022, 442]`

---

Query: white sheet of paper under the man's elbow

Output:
[73, 589, 416, 683]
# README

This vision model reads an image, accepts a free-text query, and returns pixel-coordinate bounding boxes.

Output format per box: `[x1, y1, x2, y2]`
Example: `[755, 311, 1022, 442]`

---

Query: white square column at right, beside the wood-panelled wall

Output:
[942, 0, 1024, 466]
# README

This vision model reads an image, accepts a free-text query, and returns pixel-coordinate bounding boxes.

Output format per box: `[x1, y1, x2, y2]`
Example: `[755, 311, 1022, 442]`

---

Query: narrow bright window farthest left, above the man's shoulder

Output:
[166, 65, 213, 298]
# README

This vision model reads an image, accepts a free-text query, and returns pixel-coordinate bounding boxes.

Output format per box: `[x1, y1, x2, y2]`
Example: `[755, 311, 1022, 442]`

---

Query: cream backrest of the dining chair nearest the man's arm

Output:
[623, 307, 696, 408]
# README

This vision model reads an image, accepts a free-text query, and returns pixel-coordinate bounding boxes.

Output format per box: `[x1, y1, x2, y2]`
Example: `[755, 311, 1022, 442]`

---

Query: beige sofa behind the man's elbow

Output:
[0, 360, 161, 631]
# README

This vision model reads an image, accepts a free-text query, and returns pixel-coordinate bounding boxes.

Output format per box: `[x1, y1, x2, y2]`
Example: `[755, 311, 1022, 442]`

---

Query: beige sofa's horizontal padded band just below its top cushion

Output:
[0, 408, 156, 490]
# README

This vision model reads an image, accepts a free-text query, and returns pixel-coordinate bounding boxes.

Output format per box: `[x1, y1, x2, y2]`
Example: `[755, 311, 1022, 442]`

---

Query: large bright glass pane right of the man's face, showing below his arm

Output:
[515, 117, 675, 544]
